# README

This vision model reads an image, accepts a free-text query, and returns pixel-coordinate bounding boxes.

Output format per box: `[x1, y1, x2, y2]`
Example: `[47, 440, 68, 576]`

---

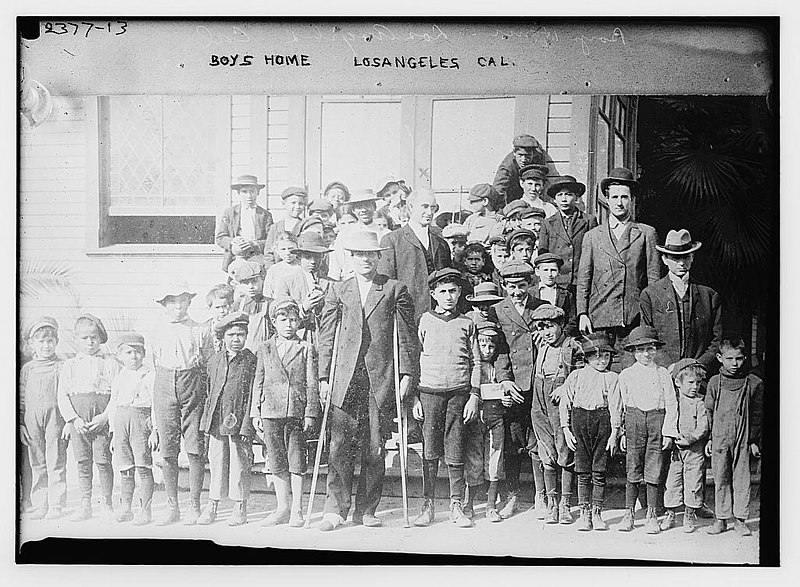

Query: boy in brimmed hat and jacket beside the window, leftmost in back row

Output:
[214, 175, 273, 271]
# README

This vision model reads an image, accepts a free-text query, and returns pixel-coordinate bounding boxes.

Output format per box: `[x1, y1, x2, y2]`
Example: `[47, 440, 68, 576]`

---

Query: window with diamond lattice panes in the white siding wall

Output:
[98, 96, 231, 247]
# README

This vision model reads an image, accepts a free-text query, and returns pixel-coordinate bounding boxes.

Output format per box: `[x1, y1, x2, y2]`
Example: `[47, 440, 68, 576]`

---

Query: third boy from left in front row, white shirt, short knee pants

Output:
[109, 332, 158, 526]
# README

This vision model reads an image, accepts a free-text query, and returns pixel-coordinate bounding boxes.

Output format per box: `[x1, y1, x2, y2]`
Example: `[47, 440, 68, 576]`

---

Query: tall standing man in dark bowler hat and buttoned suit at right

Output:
[576, 167, 661, 356]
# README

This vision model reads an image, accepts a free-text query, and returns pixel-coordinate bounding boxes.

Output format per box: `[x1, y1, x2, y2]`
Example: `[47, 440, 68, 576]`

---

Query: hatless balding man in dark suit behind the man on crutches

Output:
[378, 188, 453, 324]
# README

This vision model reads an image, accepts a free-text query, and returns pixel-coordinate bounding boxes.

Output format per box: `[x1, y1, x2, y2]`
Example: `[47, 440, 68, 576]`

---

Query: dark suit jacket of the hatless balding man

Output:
[378, 225, 453, 324]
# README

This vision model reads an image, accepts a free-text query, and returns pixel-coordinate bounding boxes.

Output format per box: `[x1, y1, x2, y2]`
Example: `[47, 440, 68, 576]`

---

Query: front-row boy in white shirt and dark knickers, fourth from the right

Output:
[558, 331, 622, 532]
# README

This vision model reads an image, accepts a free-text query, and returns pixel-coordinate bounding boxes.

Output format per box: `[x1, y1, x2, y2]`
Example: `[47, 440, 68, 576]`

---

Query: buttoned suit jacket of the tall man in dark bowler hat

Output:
[576, 222, 661, 328]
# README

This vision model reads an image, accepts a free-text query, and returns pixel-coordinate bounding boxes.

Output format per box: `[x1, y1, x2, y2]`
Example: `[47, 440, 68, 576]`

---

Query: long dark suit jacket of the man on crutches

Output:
[319, 274, 419, 412]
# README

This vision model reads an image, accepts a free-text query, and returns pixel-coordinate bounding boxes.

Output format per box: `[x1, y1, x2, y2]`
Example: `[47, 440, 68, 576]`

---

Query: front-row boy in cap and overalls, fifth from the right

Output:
[531, 304, 580, 524]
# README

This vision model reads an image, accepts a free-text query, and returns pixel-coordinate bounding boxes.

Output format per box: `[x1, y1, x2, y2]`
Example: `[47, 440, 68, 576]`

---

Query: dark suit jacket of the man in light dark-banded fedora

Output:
[639, 276, 722, 372]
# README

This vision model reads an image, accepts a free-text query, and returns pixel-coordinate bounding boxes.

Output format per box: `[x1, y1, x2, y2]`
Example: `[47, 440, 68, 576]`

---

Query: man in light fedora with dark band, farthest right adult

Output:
[639, 228, 722, 373]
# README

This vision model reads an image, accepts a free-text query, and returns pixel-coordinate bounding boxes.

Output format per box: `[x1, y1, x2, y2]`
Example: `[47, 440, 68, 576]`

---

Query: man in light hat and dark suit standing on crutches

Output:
[319, 230, 416, 531]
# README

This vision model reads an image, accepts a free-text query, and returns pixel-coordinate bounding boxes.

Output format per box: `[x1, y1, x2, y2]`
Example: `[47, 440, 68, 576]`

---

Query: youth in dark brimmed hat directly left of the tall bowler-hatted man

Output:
[539, 175, 597, 296]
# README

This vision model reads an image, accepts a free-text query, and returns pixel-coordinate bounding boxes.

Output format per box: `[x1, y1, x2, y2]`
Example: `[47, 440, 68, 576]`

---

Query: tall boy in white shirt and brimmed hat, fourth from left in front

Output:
[151, 284, 211, 526]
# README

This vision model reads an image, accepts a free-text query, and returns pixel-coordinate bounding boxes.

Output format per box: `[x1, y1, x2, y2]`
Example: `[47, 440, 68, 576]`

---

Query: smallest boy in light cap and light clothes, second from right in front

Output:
[661, 359, 708, 532]
